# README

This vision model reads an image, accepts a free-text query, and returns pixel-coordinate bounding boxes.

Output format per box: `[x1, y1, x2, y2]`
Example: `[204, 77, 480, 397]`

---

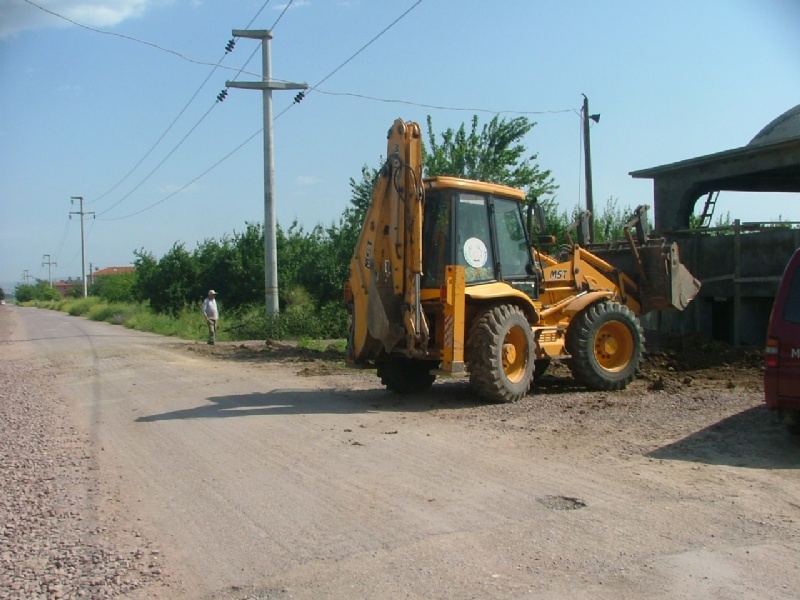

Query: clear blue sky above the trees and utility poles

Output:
[0, 0, 800, 291]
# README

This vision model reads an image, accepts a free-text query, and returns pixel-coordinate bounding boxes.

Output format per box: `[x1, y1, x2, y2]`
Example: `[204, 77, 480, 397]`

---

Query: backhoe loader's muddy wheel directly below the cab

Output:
[466, 305, 534, 402]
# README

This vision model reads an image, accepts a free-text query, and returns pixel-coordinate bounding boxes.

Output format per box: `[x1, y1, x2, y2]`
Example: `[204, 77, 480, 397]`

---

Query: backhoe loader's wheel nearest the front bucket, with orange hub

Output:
[566, 300, 644, 391]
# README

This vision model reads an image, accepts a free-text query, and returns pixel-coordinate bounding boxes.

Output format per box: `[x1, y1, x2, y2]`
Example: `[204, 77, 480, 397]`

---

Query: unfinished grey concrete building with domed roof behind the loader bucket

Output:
[631, 105, 800, 346]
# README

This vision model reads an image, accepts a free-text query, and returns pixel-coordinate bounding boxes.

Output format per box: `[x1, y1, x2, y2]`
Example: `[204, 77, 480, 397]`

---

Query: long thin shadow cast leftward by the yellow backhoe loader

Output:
[136, 382, 487, 423]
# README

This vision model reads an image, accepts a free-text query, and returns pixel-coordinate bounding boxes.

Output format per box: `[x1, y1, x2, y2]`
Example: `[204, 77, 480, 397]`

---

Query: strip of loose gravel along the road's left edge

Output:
[0, 306, 166, 600]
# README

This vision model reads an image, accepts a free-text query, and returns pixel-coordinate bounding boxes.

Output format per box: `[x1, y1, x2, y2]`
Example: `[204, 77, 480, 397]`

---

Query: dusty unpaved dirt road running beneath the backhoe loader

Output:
[0, 306, 800, 600]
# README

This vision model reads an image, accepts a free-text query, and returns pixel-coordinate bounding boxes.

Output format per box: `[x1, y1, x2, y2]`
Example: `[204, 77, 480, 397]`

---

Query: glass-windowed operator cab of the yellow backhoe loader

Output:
[421, 177, 537, 298]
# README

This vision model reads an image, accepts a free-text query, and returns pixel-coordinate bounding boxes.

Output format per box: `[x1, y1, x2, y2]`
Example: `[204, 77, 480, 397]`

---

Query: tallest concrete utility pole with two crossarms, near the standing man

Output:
[230, 29, 308, 316]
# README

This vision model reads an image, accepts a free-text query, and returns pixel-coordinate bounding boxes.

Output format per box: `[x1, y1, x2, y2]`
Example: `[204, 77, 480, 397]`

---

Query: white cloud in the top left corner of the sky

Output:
[0, 0, 153, 38]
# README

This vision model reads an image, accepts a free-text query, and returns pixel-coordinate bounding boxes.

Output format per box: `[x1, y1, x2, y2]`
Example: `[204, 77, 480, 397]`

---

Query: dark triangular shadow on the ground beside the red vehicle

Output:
[647, 406, 800, 469]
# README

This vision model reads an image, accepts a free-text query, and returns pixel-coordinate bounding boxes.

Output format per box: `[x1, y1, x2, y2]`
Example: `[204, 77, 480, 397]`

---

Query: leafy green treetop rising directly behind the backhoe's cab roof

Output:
[423, 115, 558, 198]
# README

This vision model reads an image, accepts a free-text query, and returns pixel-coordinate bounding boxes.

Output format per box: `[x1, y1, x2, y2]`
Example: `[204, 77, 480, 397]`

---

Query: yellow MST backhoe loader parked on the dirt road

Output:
[345, 119, 700, 402]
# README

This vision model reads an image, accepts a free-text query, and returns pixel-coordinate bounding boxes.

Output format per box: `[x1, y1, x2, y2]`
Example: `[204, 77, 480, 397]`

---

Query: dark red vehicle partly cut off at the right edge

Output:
[764, 248, 800, 434]
